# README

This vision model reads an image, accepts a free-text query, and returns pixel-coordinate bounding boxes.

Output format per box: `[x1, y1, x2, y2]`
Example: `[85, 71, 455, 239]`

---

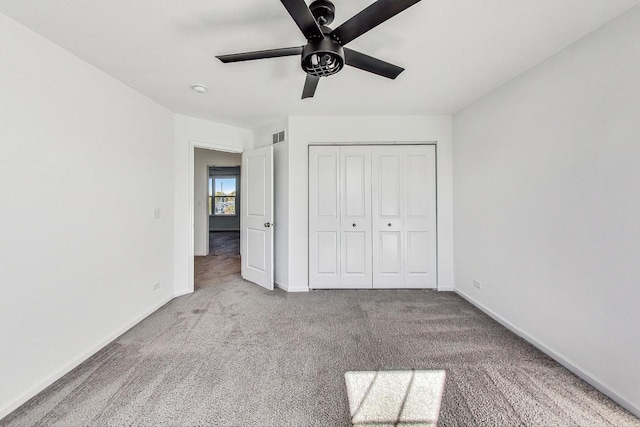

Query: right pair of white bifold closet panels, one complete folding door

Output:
[371, 145, 436, 288]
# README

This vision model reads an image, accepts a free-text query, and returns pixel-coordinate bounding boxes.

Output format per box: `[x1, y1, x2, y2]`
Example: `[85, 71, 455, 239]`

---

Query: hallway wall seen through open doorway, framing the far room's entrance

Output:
[193, 148, 242, 256]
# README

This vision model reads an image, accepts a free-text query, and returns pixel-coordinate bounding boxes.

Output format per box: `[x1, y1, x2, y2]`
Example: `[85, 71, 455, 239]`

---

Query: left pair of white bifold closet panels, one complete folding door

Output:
[309, 146, 373, 289]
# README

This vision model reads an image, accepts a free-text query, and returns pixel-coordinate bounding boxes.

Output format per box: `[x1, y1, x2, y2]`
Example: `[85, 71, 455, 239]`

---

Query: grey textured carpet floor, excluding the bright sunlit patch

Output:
[0, 251, 640, 426]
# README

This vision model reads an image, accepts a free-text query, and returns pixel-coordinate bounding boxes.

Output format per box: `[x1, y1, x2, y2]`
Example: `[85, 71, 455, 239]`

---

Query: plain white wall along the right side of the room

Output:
[454, 7, 640, 416]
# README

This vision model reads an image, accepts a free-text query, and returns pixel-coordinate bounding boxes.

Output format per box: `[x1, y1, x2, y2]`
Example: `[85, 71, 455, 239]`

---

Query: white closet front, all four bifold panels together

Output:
[309, 145, 436, 289]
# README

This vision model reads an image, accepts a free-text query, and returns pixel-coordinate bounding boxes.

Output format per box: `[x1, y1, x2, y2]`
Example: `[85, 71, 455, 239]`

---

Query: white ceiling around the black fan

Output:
[0, 0, 640, 128]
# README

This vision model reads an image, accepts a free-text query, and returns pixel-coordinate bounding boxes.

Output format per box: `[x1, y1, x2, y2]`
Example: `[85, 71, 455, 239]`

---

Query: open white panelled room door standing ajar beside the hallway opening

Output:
[240, 146, 274, 290]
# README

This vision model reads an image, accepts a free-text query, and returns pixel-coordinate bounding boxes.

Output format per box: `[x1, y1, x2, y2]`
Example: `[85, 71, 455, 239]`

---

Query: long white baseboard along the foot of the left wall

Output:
[0, 295, 174, 420]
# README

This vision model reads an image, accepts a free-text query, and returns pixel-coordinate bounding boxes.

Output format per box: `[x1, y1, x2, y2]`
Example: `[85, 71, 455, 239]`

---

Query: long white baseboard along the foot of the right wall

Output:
[455, 289, 640, 418]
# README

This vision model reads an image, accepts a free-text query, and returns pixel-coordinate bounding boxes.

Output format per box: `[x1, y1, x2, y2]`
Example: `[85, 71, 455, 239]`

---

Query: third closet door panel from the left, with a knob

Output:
[371, 146, 404, 288]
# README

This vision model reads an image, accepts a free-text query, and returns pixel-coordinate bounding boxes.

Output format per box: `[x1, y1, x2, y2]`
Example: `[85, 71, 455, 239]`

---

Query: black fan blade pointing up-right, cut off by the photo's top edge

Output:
[331, 0, 420, 46]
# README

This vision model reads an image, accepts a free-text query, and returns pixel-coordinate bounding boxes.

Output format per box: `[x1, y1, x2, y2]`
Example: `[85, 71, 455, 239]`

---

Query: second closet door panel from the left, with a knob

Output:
[340, 146, 372, 288]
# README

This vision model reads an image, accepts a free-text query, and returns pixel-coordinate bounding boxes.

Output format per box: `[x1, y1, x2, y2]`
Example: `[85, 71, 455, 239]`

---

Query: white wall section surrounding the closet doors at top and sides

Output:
[288, 116, 453, 291]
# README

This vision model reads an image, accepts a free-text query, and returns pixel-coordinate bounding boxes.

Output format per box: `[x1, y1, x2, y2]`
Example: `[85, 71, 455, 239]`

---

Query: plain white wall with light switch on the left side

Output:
[0, 14, 174, 418]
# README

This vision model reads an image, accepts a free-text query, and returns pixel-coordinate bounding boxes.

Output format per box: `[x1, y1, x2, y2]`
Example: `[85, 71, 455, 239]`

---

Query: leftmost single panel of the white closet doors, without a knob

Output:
[309, 146, 341, 289]
